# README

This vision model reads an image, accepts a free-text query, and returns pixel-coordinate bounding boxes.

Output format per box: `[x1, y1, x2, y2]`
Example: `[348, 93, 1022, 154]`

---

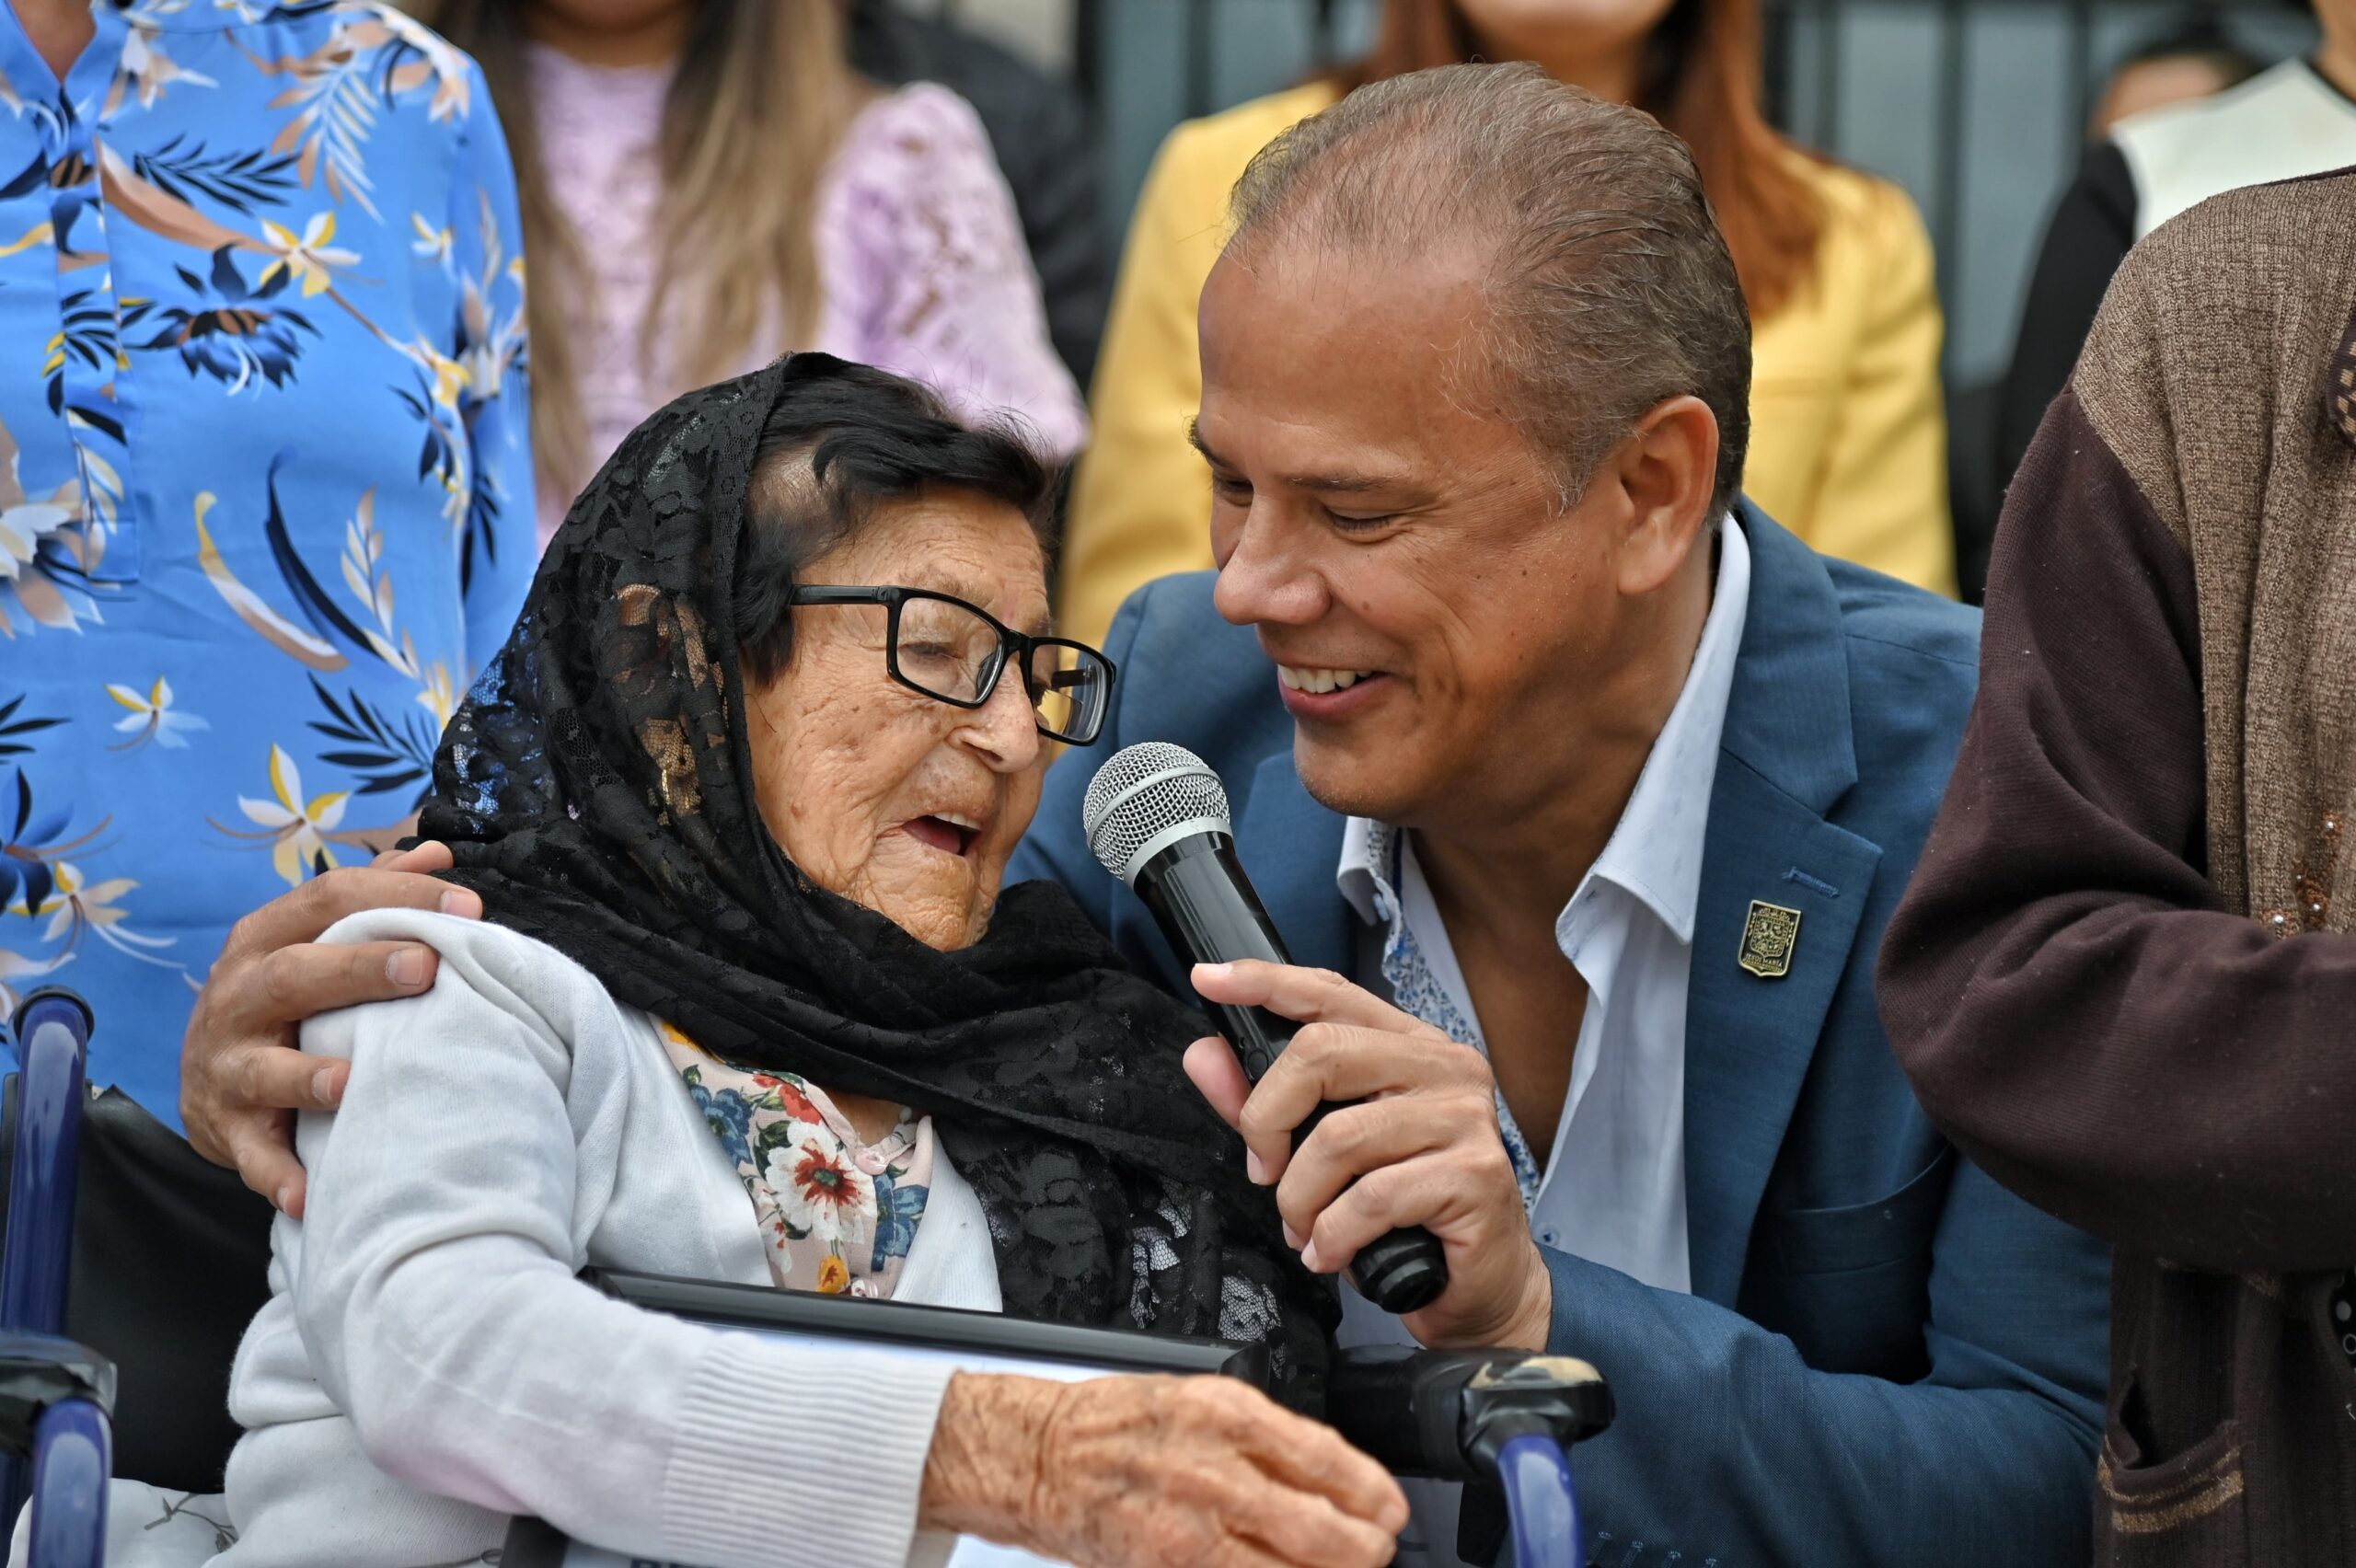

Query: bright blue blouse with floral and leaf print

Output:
[0, 0, 535, 1121]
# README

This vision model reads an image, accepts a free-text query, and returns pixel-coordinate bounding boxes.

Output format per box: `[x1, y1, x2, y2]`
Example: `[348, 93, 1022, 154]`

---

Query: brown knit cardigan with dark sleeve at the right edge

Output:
[1880, 172, 2356, 1568]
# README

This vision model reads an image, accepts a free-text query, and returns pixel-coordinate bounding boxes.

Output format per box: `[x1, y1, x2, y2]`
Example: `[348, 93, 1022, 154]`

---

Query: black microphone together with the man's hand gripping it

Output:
[1084, 742, 1553, 1349]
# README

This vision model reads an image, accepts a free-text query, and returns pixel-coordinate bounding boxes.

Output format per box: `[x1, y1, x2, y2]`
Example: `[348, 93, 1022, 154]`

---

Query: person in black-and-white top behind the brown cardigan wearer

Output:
[1995, 0, 2356, 480]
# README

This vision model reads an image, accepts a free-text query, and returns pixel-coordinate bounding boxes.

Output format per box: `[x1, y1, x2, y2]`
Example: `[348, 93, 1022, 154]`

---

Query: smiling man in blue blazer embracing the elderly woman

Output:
[186, 66, 2108, 1568]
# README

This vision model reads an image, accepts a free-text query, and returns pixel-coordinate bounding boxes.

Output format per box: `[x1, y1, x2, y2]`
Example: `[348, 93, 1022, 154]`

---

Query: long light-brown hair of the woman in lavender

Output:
[408, 0, 867, 497]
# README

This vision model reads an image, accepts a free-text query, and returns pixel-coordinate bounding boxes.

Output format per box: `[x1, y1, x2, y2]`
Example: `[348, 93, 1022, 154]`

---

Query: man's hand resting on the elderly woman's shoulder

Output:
[179, 843, 483, 1219]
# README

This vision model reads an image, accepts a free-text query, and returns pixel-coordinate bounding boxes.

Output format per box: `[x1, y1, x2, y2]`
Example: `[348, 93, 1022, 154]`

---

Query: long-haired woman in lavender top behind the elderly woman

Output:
[412, 0, 1086, 544]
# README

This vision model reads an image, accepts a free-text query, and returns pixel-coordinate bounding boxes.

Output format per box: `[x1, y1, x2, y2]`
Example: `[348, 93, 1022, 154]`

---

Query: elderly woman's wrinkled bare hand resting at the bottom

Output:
[924, 1373, 1406, 1568]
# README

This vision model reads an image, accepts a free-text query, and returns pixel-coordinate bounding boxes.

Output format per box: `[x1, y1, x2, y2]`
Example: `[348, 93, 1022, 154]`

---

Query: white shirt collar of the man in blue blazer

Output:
[1334, 515, 1750, 941]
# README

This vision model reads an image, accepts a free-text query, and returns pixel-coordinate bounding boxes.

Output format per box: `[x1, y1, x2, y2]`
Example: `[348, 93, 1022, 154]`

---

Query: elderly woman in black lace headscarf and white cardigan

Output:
[188, 355, 1406, 1568]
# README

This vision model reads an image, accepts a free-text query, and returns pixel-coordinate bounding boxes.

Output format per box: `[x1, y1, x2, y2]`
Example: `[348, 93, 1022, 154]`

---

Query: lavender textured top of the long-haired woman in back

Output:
[533, 47, 1089, 547]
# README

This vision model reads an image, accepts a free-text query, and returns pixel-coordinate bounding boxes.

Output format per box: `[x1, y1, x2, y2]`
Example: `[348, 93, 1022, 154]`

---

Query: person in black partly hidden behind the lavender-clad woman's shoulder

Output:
[850, 0, 1112, 386]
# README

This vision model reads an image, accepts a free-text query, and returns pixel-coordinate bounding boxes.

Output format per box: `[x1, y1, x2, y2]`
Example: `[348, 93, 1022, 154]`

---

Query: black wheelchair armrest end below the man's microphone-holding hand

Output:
[1326, 1344, 1611, 1481]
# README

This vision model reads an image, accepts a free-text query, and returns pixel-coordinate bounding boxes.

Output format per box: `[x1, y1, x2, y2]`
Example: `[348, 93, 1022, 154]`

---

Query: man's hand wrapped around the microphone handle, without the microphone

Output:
[1185, 961, 1555, 1352]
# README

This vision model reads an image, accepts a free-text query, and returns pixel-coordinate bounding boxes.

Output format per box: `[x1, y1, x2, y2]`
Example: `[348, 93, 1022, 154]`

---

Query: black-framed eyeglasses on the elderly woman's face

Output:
[784, 584, 1112, 746]
